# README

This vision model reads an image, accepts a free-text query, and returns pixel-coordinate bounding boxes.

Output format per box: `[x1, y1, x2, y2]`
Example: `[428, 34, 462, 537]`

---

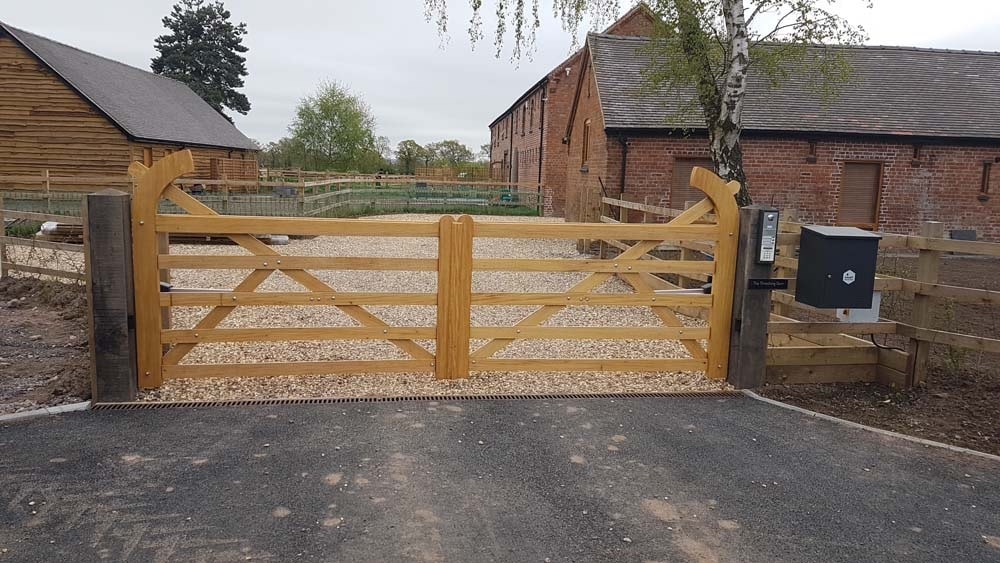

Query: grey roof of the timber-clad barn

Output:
[0, 22, 256, 150]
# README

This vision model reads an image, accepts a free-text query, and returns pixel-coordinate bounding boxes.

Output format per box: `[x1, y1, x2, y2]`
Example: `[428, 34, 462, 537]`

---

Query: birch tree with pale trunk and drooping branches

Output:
[424, 0, 871, 205]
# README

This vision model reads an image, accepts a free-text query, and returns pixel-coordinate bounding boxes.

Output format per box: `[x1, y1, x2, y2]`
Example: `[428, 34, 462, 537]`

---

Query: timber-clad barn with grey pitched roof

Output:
[0, 22, 257, 179]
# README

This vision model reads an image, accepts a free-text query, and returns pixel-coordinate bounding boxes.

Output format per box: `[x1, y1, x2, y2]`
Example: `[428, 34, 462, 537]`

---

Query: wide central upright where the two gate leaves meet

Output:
[434, 215, 474, 379]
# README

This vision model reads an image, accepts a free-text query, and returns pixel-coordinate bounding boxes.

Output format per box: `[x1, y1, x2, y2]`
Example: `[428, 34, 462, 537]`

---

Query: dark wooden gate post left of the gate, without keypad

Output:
[84, 189, 139, 403]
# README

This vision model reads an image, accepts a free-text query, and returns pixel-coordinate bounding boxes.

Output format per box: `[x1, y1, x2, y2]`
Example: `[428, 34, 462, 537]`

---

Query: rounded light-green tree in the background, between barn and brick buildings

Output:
[289, 82, 388, 171]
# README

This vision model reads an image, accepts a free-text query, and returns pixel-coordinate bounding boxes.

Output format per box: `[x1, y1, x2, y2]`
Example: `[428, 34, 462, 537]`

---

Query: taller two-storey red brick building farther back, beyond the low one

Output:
[490, 3, 655, 216]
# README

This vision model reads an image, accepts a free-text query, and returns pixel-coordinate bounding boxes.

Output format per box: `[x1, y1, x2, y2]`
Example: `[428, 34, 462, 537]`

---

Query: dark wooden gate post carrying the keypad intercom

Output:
[726, 205, 777, 389]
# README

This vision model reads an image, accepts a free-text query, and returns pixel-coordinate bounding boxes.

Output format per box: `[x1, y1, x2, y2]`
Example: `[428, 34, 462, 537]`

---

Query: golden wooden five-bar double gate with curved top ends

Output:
[131, 151, 739, 388]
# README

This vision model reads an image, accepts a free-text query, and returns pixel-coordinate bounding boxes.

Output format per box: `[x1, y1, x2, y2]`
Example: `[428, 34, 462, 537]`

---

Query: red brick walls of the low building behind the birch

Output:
[567, 133, 1000, 240]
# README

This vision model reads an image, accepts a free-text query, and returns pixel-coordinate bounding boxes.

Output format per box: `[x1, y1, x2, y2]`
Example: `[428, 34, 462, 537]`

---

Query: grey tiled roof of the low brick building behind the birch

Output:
[588, 34, 1000, 139]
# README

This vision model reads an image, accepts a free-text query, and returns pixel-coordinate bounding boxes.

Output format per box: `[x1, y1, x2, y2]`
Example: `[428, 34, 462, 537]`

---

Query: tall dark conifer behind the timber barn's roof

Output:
[150, 0, 250, 121]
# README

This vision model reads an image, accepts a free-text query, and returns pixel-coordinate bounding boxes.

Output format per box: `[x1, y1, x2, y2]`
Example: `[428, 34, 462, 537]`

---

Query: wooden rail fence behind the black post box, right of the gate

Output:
[599, 198, 1000, 386]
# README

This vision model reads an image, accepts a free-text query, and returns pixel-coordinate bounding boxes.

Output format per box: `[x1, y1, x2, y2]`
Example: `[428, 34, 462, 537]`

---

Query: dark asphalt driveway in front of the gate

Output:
[0, 397, 1000, 563]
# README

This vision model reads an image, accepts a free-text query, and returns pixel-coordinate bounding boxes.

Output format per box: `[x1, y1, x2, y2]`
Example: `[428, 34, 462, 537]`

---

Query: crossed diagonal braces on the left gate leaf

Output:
[163, 186, 434, 365]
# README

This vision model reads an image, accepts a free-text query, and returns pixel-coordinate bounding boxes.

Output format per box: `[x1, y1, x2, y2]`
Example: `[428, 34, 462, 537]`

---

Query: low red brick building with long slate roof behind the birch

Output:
[562, 34, 1000, 240]
